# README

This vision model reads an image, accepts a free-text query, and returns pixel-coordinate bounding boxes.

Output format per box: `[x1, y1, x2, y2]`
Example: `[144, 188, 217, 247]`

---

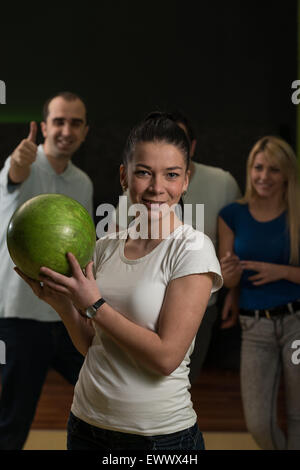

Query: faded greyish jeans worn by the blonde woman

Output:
[240, 312, 300, 450]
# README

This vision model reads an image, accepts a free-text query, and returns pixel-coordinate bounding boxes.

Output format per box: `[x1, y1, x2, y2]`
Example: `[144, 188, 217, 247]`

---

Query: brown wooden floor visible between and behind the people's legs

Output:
[32, 368, 285, 432]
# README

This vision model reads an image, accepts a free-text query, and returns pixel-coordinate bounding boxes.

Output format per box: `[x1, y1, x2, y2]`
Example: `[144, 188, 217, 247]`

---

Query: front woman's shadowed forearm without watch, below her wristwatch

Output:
[57, 305, 94, 356]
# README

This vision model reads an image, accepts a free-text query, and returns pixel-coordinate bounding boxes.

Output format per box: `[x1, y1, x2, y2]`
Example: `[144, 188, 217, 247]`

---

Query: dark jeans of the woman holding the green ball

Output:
[67, 412, 205, 451]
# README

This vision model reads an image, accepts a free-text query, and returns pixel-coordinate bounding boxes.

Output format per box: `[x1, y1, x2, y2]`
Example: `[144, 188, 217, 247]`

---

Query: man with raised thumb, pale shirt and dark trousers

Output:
[0, 92, 93, 450]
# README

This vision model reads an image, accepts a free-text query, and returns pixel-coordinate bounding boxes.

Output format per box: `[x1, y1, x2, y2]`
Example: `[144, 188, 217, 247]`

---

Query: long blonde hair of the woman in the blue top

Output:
[239, 136, 300, 265]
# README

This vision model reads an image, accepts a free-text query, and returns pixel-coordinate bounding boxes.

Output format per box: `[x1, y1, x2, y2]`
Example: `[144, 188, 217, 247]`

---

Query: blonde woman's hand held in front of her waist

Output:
[240, 261, 284, 286]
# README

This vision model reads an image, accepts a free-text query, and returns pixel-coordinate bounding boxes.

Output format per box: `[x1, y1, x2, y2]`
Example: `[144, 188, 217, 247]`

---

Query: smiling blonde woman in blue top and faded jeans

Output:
[219, 136, 300, 450]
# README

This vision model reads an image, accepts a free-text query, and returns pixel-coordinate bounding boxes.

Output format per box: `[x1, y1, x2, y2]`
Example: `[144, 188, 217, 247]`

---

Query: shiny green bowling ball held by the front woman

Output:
[7, 194, 96, 280]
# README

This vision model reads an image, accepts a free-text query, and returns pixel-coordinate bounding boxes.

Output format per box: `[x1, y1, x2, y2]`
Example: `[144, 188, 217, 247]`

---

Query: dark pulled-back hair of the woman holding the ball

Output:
[123, 111, 190, 170]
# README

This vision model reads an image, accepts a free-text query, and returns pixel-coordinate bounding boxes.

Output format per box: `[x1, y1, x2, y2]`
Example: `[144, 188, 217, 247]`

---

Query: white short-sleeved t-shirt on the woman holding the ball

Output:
[71, 225, 222, 435]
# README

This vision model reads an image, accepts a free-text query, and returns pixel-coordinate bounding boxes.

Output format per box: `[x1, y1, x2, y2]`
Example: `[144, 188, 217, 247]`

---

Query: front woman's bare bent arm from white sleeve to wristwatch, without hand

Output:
[91, 274, 212, 375]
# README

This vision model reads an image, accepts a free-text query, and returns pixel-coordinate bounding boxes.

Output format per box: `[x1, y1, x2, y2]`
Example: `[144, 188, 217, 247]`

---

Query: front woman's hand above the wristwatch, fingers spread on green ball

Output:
[40, 253, 101, 310]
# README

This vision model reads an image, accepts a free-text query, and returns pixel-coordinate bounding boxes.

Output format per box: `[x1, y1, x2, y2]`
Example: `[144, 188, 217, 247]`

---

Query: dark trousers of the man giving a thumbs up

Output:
[0, 318, 84, 450]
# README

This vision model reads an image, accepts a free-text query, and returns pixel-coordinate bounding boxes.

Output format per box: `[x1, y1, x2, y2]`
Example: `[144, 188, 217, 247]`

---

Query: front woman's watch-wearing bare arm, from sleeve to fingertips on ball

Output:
[42, 255, 212, 375]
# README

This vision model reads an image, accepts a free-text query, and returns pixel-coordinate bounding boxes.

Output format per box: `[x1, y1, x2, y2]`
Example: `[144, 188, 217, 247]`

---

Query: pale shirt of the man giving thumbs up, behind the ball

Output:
[0, 145, 93, 321]
